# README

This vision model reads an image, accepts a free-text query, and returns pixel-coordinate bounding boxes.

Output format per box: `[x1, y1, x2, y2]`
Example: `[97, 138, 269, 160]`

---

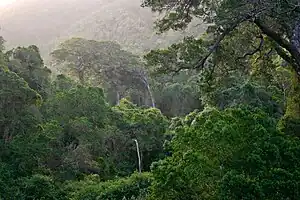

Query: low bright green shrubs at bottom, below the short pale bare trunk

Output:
[67, 173, 152, 200]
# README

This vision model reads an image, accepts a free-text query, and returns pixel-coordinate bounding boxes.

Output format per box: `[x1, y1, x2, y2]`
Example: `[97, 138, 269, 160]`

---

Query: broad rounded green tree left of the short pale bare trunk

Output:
[42, 86, 115, 179]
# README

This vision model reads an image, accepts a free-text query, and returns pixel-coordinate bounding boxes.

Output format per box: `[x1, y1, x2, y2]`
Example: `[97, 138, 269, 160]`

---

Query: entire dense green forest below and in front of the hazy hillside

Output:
[0, 0, 300, 200]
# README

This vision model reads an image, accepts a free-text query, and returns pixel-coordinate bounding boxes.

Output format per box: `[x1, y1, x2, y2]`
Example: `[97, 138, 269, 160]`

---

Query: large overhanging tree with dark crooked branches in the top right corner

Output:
[143, 0, 300, 134]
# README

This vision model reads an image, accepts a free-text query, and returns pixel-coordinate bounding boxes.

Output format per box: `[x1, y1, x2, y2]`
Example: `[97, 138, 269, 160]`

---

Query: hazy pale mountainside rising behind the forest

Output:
[0, 0, 203, 57]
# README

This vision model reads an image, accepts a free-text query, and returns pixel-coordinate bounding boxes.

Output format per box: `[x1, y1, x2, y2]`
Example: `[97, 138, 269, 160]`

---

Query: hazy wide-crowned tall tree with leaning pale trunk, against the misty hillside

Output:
[51, 38, 155, 107]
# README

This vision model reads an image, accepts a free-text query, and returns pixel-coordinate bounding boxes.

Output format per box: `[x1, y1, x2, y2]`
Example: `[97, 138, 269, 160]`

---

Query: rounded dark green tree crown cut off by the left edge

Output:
[0, 69, 41, 141]
